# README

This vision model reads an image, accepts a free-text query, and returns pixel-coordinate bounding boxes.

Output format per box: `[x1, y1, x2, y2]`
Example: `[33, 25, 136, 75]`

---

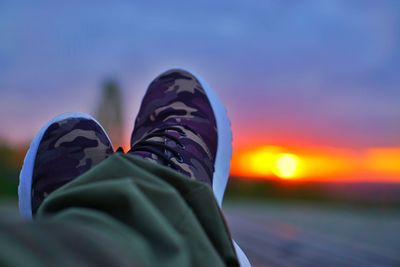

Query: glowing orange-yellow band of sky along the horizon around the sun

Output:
[231, 146, 400, 182]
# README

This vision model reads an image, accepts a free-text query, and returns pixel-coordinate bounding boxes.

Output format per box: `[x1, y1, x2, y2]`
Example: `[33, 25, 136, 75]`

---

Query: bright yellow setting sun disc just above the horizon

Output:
[272, 153, 299, 179]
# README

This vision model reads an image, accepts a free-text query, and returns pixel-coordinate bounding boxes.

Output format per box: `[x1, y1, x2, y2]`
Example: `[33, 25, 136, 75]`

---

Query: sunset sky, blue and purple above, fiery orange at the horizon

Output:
[0, 0, 400, 182]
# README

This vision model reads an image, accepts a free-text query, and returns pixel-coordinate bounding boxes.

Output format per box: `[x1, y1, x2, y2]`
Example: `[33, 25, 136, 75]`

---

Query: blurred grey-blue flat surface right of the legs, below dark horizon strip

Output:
[224, 203, 400, 267]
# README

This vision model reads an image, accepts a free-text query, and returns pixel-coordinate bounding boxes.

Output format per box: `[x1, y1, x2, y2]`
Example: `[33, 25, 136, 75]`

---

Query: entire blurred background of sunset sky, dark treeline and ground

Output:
[0, 0, 400, 266]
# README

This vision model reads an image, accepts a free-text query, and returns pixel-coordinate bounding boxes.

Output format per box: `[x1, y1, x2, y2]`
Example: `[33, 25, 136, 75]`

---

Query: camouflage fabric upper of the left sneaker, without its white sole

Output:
[32, 118, 113, 214]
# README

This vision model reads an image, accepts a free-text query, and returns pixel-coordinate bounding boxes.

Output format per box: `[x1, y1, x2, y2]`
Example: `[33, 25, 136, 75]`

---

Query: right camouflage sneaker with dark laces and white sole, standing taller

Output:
[129, 70, 232, 207]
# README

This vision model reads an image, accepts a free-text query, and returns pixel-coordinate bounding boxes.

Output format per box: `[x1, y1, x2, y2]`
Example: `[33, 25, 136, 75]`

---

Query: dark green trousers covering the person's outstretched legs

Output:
[0, 153, 238, 267]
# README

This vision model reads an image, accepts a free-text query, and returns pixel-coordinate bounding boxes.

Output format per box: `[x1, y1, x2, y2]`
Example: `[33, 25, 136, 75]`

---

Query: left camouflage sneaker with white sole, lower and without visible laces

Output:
[18, 113, 113, 219]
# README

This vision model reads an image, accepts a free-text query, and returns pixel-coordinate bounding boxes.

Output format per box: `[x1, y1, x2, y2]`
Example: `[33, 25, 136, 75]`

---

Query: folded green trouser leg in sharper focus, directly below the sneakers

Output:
[36, 153, 237, 266]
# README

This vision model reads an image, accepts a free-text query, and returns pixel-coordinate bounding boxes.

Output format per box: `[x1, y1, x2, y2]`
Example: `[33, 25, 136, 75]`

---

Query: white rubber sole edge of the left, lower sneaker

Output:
[18, 112, 112, 220]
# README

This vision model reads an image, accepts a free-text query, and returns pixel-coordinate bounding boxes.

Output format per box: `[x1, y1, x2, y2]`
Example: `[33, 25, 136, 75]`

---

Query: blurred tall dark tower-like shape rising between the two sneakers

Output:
[96, 80, 123, 146]
